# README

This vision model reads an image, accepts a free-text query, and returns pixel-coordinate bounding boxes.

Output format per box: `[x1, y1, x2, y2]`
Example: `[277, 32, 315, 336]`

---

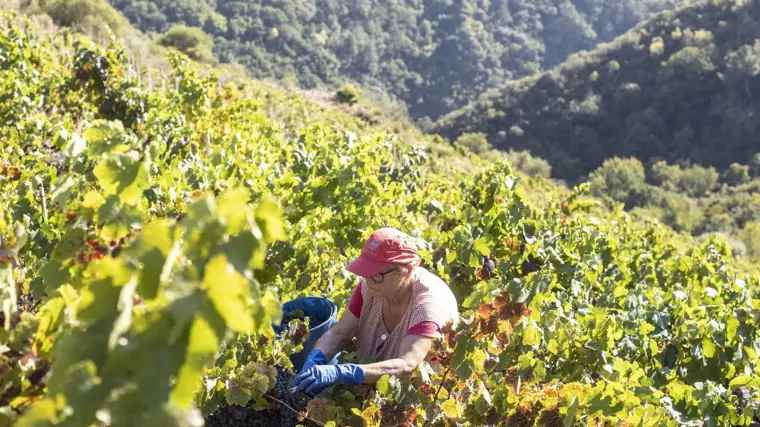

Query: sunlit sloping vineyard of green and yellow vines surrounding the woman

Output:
[0, 15, 760, 427]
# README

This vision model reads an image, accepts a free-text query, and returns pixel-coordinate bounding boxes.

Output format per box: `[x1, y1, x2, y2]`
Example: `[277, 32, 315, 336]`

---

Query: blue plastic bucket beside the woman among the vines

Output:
[275, 297, 338, 372]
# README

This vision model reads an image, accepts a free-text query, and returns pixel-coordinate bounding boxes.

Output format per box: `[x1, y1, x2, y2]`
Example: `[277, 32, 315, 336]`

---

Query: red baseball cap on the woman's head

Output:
[346, 227, 417, 277]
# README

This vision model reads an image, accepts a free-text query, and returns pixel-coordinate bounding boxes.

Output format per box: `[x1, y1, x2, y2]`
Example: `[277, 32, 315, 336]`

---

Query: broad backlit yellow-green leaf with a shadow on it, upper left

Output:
[93, 153, 148, 206]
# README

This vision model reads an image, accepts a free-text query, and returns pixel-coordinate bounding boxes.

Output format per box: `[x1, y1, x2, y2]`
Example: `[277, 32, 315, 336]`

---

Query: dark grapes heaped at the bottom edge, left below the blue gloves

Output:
[206, 366, 317, 427]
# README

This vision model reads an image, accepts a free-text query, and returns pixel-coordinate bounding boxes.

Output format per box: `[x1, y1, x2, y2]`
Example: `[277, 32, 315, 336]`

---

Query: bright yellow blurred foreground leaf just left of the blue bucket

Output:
[201, 254, 254, 333]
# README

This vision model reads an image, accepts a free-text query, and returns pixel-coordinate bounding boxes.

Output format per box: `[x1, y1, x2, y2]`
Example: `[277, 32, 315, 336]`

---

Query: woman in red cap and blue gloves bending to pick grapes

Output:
[291, 228, 459, 394]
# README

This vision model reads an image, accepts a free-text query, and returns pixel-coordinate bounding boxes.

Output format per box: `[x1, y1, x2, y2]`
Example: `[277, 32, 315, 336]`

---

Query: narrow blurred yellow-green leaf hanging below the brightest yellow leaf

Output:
[171, 315, 220, 409]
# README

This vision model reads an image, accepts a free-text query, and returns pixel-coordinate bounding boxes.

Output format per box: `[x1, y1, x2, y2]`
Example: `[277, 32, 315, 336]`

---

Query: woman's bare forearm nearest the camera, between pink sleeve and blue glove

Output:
[360, 335, 433, 384]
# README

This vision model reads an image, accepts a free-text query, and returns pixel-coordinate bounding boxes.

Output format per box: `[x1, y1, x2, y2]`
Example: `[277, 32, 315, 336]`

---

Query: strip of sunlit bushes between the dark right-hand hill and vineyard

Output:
[589, 157, 760, 263]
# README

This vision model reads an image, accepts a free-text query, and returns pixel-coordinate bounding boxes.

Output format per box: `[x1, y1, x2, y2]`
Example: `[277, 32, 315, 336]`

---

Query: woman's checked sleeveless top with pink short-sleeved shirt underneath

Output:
[348, 267, 459, 360]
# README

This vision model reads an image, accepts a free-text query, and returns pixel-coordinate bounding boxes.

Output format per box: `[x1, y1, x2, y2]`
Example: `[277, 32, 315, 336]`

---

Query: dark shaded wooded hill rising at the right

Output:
[435, 0, 760, 181]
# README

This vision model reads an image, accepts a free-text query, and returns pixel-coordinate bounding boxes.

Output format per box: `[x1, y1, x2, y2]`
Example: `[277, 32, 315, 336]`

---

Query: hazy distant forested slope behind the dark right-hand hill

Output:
[104, 0, 679, 119]
